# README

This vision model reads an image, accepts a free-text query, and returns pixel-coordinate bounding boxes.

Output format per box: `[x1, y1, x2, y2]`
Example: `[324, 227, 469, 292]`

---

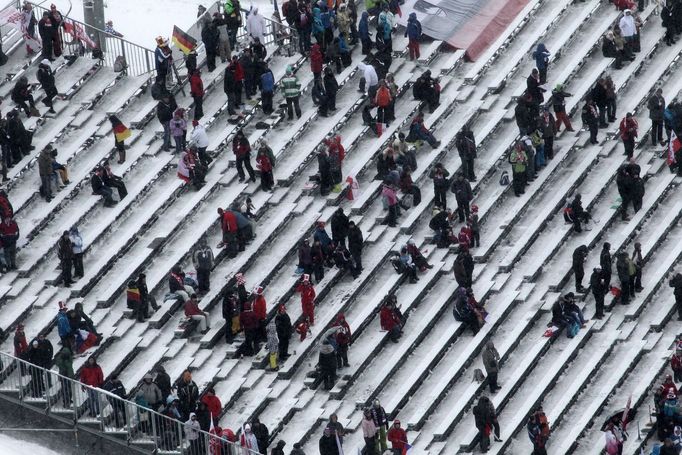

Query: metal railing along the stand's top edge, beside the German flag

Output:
[21, 0, 155, 76]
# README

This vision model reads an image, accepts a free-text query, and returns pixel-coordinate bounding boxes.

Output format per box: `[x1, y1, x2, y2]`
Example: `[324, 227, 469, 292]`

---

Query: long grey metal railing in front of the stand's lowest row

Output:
[0, 352, 259, 455]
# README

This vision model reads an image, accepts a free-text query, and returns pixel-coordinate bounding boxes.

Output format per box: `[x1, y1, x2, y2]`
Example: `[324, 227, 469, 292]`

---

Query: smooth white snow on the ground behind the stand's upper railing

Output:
[68, 0, 281, 49]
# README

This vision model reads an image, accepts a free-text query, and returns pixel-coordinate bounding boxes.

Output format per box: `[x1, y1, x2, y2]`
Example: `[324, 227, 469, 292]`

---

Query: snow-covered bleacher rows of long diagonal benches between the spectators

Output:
[0, 0, 682, 454]
